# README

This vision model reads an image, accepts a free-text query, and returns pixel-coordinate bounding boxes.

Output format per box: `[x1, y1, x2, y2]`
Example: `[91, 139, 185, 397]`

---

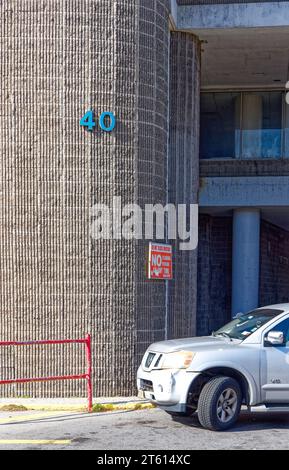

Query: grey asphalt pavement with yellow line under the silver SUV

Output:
[0, 409, 289, 450]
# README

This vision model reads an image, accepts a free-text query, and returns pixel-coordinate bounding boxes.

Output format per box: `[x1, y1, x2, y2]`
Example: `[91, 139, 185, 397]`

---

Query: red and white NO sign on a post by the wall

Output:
[148, 243, 173, 279]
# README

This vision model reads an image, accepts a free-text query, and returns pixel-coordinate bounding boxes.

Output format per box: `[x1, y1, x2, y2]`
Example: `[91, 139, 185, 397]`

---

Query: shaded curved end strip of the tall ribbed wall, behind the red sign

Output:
[135, 0, 169, 365]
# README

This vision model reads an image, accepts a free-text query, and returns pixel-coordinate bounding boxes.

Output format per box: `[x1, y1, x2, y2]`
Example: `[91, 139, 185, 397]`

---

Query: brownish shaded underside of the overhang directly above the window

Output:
[199, 26, 289, 89]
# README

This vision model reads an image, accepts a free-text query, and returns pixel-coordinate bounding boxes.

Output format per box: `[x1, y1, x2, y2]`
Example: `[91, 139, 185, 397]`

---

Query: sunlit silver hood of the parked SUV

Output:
[148, 336, 242, 353]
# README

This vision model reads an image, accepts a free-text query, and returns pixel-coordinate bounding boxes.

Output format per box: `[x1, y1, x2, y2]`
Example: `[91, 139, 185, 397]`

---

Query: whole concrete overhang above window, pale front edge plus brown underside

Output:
[171, 0, 289, 88]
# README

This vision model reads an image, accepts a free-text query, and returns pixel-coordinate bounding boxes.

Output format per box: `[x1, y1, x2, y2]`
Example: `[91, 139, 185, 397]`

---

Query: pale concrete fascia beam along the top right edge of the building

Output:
[174, 2, 289, 30]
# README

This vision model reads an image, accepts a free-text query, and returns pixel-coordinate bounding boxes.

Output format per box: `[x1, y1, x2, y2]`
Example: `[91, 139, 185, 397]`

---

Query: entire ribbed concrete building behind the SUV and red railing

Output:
[0, 0, 289, 396]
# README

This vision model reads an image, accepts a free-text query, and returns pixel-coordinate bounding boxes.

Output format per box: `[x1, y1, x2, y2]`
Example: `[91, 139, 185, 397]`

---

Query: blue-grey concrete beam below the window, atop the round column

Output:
[199, 176, 289, 208]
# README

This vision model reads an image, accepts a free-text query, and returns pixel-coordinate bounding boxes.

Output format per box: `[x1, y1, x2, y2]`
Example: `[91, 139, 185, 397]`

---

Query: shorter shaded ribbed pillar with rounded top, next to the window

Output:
[168, 32, 201, 337]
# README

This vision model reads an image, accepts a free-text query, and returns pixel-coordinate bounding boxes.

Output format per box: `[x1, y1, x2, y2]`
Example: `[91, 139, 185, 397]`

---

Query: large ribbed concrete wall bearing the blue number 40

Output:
[0, 0, 169, 396]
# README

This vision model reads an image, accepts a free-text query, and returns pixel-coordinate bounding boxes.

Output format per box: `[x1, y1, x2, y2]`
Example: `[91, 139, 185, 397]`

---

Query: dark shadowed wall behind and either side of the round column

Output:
[197, 215, 289, 336]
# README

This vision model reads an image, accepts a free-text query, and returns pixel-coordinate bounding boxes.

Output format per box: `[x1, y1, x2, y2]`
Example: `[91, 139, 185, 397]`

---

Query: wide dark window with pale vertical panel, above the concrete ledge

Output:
[200, 91, 282, 159]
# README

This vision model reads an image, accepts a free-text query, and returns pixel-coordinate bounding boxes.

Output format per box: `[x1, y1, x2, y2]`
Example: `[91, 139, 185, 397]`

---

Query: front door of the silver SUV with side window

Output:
[260, 318, 289, 403]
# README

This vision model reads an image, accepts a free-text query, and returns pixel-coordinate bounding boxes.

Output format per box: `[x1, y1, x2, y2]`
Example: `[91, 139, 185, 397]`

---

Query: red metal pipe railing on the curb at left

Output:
[0, 335, 92, 412]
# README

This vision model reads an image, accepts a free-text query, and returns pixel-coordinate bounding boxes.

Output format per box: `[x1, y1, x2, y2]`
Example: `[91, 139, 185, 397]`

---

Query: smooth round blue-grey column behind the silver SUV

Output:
[232, 208, 261, 315]
